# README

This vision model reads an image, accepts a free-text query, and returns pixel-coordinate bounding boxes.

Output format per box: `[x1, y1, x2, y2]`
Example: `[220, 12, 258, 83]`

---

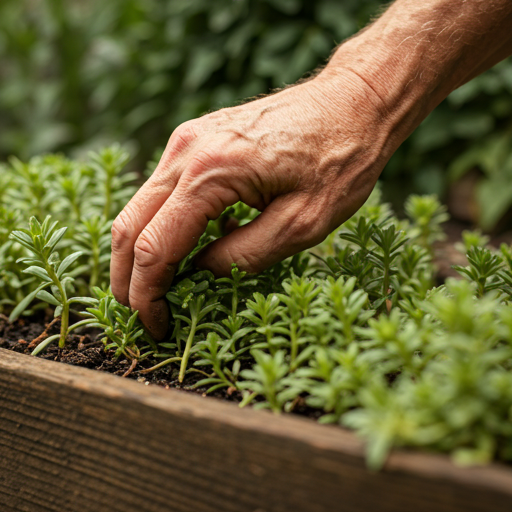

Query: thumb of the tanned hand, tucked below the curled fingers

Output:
[195, 195, 326, 277]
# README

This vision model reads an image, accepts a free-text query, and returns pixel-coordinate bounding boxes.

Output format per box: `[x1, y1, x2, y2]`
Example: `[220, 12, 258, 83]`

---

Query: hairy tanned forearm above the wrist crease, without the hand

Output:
[321, 0, 512, 144]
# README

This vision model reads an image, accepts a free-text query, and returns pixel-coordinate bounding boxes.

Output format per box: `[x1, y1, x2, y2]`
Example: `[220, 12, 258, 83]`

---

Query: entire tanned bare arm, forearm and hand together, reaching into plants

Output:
[111, 0, 512, 339]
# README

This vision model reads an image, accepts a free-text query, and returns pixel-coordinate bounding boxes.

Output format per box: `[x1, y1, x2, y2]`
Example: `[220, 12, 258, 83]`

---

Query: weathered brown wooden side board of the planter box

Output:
[0, 350, 512, 512]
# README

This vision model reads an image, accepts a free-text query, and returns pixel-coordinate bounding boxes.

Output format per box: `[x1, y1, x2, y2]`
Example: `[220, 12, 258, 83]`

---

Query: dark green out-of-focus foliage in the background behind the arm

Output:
[0, 0, 512, 225]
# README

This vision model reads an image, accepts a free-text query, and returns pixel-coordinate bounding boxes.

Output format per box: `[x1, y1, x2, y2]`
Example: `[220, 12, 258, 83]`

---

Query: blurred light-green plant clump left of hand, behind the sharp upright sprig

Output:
[0, 145, 136, 314]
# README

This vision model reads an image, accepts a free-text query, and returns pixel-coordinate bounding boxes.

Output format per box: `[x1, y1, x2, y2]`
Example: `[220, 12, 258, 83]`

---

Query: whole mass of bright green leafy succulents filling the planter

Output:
[5, 147, 512, 468]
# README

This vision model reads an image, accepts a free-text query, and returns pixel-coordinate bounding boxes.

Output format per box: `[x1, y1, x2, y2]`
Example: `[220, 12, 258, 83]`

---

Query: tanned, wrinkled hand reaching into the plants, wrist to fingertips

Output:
[111, 70, 402, 339]
